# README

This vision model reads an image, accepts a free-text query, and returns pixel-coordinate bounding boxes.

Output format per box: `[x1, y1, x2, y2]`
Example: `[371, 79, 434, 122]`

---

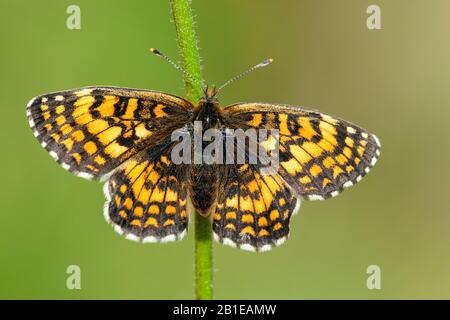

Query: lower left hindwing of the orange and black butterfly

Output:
[104, 144, 189, 243]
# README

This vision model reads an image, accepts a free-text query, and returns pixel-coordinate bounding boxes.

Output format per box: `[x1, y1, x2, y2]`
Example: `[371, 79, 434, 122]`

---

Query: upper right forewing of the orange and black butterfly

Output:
[224, 103, 380, 200]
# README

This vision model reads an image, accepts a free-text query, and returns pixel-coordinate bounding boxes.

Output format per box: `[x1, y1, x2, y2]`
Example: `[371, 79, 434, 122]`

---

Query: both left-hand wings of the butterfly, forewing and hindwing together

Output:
[27, 87, 193, 242]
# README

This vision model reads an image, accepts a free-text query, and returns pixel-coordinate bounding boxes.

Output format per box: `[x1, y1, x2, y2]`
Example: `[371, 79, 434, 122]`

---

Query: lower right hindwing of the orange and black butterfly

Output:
[213, 164, 300, 251]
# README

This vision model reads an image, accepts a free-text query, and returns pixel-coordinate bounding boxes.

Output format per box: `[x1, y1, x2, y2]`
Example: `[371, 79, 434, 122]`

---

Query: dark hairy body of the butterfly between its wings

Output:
[189, 88, 222, 216]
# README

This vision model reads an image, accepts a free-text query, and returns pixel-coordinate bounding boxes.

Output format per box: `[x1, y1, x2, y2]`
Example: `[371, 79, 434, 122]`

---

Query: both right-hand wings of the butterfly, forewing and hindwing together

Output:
[213, 103, 381, 251]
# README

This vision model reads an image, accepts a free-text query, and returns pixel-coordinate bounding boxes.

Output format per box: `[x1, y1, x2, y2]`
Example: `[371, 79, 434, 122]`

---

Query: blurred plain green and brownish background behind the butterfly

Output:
[0, 0, 450, 299]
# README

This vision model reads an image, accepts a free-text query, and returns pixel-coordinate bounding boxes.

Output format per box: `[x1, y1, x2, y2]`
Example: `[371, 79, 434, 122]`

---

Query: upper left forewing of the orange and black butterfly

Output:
[27, 87, 193, 179]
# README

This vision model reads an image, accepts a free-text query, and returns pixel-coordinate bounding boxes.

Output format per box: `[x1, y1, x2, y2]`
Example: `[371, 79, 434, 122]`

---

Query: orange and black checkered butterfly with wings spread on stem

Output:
[27, 55, 380, 251]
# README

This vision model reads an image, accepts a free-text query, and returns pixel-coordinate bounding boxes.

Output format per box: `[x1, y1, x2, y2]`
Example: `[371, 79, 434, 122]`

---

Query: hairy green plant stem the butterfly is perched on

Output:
[170, 0, 213, 300]
